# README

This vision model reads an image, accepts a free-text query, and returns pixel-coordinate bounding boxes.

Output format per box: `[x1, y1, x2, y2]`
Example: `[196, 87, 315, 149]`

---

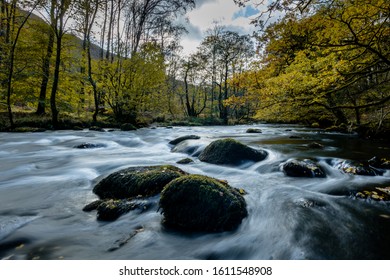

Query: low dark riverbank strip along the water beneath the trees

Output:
[0, 112, 390, 140]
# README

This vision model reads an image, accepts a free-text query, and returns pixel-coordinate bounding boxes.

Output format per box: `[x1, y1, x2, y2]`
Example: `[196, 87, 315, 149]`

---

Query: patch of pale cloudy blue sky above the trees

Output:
[181, 0, 260, 55]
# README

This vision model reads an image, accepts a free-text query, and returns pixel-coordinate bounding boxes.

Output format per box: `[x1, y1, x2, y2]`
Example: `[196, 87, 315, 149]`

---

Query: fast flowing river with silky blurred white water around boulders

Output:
[0, 124, 390, 259]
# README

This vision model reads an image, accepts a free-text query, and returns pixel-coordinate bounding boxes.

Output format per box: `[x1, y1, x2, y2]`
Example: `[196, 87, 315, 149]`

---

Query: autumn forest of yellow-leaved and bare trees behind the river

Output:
[0, 0, 390, 137]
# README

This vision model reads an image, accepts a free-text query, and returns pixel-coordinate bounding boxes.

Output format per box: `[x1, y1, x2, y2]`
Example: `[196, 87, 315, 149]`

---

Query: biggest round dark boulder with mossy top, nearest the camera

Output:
[160, 175, 248, 232]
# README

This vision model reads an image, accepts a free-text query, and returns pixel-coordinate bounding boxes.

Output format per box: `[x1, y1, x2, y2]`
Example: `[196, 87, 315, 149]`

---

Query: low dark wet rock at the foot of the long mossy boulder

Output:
[83, 199, 151, 221]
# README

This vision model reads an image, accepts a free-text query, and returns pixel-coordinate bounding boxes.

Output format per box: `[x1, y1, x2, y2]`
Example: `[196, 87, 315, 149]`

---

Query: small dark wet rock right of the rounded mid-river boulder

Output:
[282, 159, 326, 178]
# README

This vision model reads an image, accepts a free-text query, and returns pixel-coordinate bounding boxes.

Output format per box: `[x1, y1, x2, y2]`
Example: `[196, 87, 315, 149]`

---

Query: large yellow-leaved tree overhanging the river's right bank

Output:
[235, 0, 390, 129]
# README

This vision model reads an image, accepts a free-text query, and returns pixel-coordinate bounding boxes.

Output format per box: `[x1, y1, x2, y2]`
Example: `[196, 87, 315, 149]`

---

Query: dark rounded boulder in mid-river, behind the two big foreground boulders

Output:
[199, 138, 268, 165]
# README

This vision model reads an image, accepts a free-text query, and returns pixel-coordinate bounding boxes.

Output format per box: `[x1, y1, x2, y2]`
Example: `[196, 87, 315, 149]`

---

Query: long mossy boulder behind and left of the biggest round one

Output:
[93, 165, 187, 199]
